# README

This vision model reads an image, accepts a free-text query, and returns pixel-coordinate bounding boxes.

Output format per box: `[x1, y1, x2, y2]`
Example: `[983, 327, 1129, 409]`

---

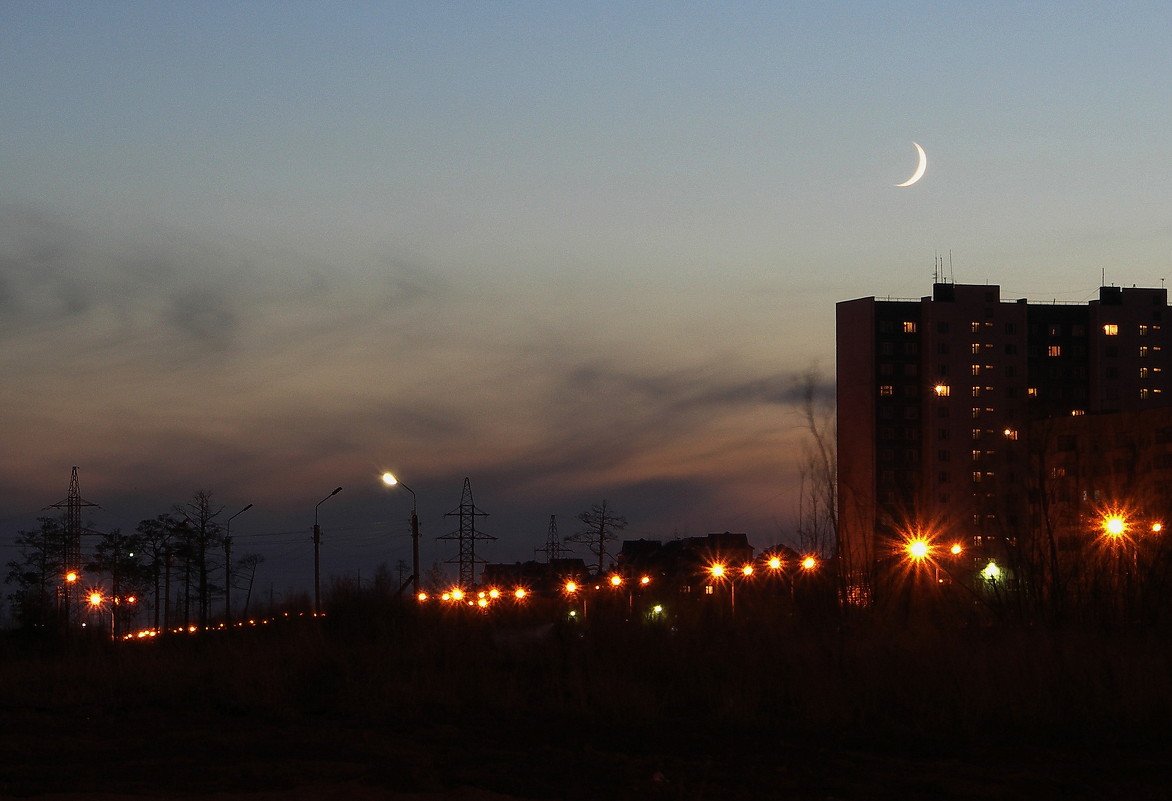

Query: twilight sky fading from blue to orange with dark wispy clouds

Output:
[0, 0, 1172, 591]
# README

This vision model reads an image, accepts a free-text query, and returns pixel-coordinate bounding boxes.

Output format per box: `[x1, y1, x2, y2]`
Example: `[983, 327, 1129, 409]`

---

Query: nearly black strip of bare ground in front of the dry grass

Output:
[0, 710, 1172, 801]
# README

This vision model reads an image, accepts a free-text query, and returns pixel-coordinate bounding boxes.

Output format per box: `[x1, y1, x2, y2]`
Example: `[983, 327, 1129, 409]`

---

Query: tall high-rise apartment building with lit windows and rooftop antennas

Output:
[837, 284, 1172, 595]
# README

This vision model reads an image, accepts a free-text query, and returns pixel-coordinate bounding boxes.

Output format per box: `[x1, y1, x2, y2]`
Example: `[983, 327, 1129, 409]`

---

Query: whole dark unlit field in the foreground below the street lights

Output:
[0, 604, 1172, 801]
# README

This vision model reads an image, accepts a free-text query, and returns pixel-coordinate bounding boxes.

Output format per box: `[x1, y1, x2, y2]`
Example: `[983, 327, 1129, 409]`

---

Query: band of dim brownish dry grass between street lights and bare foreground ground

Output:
[0, 599, 1172, 797]
